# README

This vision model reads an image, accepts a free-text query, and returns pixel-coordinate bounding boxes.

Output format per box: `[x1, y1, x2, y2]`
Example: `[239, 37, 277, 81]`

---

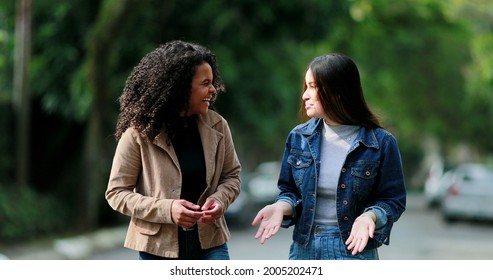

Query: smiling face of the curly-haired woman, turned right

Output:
[187, 62, 216, 116]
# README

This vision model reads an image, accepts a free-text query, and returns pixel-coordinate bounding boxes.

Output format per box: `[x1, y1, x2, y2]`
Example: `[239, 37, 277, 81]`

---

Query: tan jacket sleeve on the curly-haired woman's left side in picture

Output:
[105, 129, 173, 223]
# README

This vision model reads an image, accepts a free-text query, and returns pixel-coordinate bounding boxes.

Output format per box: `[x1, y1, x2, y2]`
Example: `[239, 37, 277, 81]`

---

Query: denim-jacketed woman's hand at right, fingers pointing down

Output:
[346, 211, 377, 255]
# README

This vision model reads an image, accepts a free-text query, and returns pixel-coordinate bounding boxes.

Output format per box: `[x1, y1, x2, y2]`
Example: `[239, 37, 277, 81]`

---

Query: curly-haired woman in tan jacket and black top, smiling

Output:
[105, 41, 241, 260]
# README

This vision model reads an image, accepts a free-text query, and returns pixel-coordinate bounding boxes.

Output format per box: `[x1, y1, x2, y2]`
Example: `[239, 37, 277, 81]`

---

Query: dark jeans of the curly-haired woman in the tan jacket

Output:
[139, 228, 230, 260]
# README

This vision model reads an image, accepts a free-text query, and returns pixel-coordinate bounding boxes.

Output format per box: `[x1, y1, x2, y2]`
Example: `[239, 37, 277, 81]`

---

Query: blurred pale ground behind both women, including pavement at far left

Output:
[0, 193, 493, 260]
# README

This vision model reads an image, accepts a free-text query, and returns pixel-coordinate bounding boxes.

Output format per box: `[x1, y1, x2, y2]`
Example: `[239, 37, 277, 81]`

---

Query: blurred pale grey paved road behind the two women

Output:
[86, 194, 493, 260]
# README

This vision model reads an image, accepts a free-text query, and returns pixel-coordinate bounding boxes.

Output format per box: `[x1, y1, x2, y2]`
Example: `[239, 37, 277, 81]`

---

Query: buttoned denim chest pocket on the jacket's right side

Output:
[351, 161, 379, 196]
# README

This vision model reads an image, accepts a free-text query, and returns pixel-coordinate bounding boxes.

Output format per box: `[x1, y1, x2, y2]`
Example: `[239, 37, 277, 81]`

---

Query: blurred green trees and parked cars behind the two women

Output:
[0, 0, 493, 258]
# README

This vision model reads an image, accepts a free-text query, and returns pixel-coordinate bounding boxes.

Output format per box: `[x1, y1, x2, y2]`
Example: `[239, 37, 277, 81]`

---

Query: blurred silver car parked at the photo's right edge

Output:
[442, 163, 493, 222]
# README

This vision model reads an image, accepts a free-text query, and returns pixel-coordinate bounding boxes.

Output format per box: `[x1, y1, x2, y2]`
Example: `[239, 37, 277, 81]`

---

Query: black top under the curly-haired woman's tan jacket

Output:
[171, 116, 206, 204]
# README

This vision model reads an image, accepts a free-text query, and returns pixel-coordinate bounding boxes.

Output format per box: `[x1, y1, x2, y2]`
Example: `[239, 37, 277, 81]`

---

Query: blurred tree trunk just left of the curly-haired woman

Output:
[78, 0, 135, 229]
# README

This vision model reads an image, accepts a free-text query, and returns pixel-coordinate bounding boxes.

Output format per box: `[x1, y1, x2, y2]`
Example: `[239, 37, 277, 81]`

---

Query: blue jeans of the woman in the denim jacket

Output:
[289, 226, 378, 260]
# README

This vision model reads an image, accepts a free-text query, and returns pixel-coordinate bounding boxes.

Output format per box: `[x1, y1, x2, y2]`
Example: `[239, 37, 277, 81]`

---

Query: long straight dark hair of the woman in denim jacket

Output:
[301, 53, 381, 128]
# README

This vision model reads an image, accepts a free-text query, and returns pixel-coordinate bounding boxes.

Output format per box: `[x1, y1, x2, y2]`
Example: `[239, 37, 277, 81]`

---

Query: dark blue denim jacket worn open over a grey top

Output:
[276, 118, 406, 249]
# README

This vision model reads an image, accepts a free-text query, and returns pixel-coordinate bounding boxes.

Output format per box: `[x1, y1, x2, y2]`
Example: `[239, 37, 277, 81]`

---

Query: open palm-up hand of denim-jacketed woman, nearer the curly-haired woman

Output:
[252, 202, 291, 244]
